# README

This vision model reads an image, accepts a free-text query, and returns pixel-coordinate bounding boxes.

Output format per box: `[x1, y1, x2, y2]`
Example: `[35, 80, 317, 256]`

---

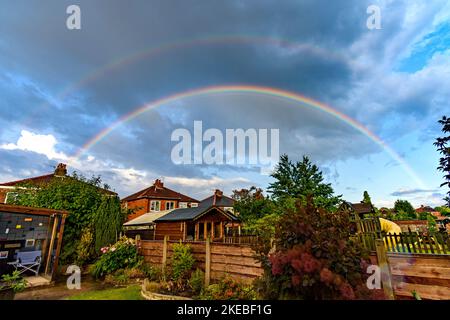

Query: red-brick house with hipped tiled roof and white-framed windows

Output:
[122, 179, 199, 221]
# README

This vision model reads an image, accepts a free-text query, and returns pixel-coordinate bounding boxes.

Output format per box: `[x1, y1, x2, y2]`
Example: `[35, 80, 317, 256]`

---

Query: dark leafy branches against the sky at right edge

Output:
[434, 116, 450, 207]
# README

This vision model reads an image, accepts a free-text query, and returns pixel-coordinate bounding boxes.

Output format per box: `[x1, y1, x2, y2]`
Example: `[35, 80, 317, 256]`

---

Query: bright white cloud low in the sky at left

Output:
[0, 130, 68, 160]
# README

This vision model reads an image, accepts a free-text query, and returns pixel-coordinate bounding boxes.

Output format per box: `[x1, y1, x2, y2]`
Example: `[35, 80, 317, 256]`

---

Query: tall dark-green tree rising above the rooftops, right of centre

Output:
[268, 154, 341, 209]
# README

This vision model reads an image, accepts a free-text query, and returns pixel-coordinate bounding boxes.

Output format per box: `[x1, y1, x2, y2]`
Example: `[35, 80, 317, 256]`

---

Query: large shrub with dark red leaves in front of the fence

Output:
[256, 199, 383, 300]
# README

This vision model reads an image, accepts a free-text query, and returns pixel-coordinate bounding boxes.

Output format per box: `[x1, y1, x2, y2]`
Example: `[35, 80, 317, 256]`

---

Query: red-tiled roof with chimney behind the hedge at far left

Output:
[0, 163, 117, 204]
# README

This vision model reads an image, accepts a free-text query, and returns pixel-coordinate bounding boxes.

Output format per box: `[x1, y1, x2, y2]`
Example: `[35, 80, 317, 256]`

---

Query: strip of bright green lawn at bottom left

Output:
[68, 285, 144, 300]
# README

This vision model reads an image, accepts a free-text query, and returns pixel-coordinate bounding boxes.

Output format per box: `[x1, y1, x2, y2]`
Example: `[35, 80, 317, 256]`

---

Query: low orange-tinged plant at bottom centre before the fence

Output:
[200, 276, 256, 300]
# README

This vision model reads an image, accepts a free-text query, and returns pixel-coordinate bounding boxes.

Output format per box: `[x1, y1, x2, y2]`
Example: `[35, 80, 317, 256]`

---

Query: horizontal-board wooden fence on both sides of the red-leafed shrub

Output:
[138, 237, 450, 299]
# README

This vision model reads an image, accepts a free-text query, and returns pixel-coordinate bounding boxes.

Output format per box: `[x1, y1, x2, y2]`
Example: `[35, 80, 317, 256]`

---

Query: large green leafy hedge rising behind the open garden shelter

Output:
[14, 172, 123, 264]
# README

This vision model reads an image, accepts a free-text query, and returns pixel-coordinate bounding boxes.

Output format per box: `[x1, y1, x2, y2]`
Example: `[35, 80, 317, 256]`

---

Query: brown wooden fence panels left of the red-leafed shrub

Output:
[138, 237, 263, 283]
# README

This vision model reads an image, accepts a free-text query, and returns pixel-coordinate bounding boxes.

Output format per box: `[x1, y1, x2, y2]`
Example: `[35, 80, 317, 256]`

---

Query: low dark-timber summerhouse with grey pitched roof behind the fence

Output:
[124, 190, 241, 241]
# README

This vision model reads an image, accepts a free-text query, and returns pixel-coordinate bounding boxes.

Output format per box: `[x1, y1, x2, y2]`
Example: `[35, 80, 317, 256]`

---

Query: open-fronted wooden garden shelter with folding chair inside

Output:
[0, 204, 69, 281]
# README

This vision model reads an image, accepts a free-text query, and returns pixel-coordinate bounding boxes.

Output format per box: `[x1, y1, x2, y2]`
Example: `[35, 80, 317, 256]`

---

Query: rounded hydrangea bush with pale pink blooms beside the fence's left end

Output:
[91, 237, 141, 278]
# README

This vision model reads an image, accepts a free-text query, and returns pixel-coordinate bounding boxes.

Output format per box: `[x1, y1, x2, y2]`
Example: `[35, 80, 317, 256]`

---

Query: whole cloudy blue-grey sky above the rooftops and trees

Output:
[0, 0, 450, 206]
